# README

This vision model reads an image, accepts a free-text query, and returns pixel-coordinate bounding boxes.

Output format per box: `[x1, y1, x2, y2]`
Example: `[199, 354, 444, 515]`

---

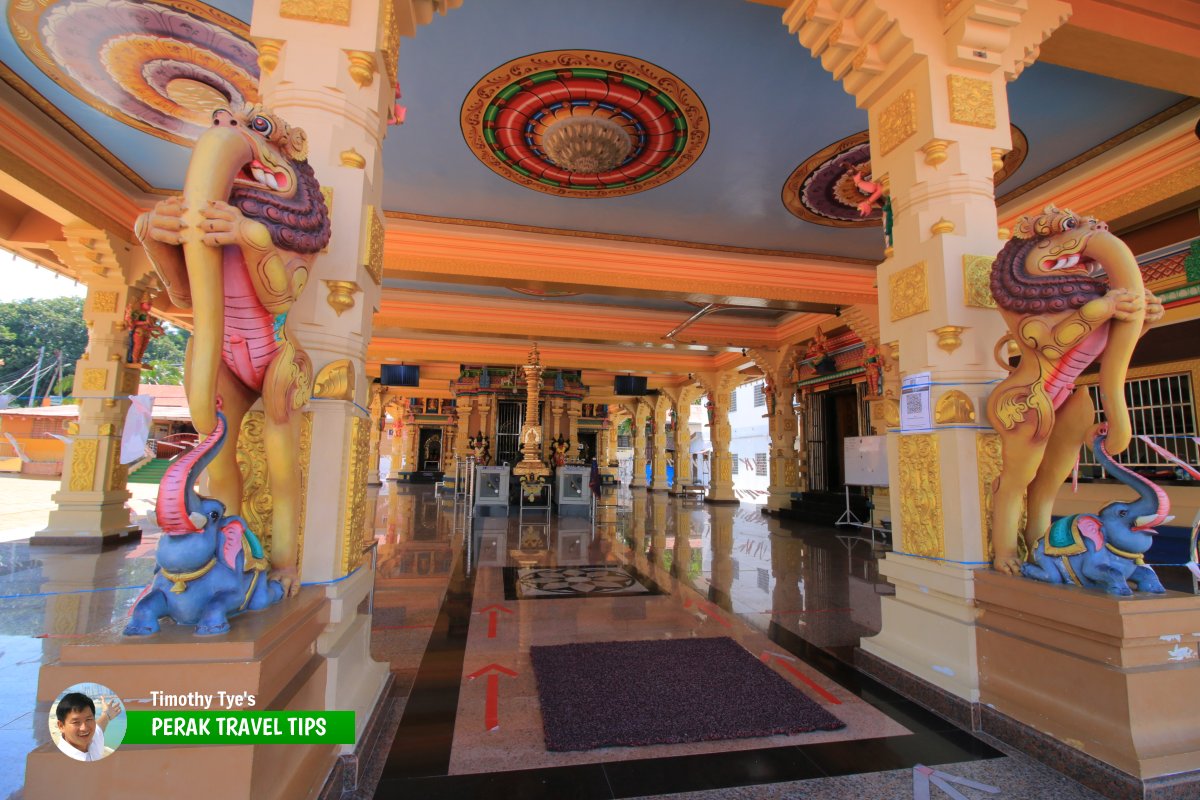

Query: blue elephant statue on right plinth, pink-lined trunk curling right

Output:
[1021, 429, 1174, 596]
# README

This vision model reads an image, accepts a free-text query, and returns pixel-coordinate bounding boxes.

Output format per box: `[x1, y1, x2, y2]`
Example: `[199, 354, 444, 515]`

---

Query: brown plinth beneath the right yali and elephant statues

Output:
[974, 571, 1200, 777]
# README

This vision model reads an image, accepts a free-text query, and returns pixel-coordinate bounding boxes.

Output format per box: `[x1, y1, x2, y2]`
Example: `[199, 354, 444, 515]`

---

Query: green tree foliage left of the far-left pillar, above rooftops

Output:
[0, 297, 88, 405]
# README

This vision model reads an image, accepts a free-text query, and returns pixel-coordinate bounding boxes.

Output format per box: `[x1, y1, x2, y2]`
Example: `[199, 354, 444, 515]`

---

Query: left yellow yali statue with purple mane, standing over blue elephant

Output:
[136, 106, 330, 596]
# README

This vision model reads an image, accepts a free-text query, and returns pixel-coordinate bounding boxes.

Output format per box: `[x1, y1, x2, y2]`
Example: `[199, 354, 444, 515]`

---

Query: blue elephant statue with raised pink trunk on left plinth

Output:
[125, 413, 283, 636]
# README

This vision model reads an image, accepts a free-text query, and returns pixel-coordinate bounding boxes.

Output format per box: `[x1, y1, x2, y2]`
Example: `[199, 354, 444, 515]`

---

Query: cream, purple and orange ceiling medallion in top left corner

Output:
[8, 0, 258, 145]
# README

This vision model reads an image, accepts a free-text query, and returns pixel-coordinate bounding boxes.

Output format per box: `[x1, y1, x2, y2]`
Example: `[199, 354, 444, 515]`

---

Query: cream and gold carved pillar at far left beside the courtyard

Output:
[32, 223, 152, 547]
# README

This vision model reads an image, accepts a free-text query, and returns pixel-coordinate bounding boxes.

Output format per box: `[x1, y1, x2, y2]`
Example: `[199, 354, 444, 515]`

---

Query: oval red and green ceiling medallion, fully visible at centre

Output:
[461, 50, 708, 197]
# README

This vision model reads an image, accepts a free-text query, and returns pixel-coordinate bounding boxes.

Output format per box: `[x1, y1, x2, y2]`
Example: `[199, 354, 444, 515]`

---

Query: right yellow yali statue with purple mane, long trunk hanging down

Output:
[988, 206, 1163, 576]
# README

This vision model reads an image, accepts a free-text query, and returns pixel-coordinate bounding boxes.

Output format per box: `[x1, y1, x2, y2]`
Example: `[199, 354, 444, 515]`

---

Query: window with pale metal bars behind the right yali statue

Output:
[1079, 372, 1200, 477]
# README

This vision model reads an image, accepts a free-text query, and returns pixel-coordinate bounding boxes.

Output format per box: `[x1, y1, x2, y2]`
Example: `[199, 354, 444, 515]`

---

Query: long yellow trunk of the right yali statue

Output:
[1085, 229, 1146, 456]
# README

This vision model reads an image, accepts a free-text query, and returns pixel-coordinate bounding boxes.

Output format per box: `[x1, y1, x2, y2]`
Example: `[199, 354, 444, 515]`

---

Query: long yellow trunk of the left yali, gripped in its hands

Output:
[181, 126, 254, 434]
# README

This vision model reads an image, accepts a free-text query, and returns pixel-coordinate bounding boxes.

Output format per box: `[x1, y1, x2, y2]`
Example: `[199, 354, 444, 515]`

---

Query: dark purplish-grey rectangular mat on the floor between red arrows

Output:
[529, 637, 846, 751]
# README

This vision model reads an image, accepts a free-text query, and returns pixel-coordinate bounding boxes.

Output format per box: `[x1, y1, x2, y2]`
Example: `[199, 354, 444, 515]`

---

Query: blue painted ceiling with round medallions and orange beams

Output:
[0, 0, 1183, 386]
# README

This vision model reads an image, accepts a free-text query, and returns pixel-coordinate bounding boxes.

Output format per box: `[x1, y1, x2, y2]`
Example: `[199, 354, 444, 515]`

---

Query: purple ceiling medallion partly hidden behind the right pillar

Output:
[782, 125, 1028, 228]
